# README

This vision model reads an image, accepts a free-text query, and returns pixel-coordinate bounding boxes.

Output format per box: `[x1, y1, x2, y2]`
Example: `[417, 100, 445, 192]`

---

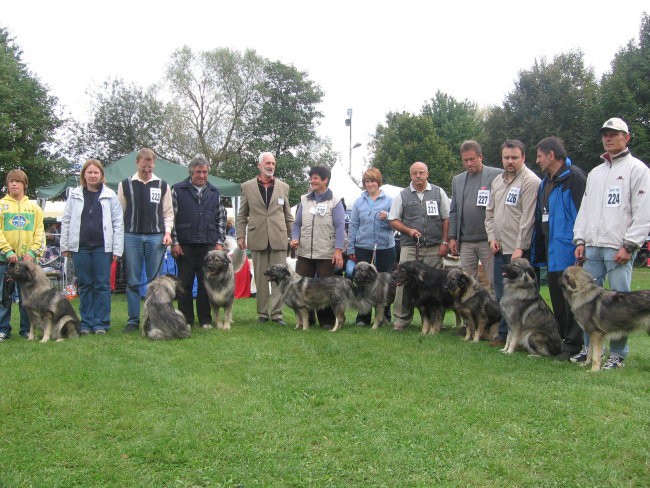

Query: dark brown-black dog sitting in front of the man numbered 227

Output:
[447, 268, 501, 342]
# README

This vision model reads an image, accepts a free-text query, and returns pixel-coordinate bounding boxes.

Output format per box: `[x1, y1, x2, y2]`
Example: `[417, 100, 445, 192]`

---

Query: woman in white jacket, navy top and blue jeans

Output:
[61, 159, 124, 335]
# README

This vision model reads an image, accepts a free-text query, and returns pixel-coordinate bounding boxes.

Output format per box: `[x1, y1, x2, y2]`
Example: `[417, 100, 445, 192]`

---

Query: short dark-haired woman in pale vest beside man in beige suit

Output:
[291, 166, 345, 329]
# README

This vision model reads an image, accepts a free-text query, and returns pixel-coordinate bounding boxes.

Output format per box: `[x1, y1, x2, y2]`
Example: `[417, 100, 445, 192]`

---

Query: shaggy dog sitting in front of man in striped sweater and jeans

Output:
[140, 275, 192, 341]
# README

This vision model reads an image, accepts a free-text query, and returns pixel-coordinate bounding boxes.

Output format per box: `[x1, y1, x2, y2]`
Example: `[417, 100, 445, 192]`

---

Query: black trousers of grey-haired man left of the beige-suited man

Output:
[176, 244, 214, 326]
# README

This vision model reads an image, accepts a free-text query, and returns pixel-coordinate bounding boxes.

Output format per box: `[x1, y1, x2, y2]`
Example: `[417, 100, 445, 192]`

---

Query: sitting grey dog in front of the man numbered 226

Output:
[500, 258, 562, 356]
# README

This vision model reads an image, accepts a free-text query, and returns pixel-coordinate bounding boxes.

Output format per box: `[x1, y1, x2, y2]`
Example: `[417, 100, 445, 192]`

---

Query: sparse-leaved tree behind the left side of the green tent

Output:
[72, 79, 168, 163]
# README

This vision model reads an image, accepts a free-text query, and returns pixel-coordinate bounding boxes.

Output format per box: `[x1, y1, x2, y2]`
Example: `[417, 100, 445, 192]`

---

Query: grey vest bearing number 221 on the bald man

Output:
[400, 185, 442, 247]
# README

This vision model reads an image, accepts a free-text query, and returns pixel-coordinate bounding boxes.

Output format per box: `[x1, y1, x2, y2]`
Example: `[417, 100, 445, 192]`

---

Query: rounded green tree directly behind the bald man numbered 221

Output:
[370, 112, 458, 195]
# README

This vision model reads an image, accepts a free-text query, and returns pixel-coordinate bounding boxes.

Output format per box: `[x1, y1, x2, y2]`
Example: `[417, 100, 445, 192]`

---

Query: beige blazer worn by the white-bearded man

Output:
[236, 178, 293, 251]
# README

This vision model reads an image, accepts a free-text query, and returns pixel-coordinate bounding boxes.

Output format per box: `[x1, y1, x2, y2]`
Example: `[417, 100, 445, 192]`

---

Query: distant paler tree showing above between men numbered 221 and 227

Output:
[422, 91, 484, 158]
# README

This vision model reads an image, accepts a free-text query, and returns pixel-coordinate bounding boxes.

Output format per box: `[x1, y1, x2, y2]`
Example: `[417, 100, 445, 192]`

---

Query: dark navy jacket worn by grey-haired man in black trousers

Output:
[173, 178, 221, 245]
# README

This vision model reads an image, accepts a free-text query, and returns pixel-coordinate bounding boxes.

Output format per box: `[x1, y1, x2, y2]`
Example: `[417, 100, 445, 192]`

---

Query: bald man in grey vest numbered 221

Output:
[388, 162, 449, 330]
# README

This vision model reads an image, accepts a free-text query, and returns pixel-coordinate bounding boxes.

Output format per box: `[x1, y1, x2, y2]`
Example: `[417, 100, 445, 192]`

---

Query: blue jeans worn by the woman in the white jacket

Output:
[72, 246, 113, 331]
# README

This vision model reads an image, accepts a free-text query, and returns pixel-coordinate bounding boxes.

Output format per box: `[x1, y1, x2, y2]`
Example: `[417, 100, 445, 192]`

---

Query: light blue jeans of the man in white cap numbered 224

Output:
[584, 246, 636, 358]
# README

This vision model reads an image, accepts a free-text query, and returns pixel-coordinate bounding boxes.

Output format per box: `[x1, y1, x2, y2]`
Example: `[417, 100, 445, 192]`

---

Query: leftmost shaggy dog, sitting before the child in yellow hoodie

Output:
[7, 261, 81, 342]
